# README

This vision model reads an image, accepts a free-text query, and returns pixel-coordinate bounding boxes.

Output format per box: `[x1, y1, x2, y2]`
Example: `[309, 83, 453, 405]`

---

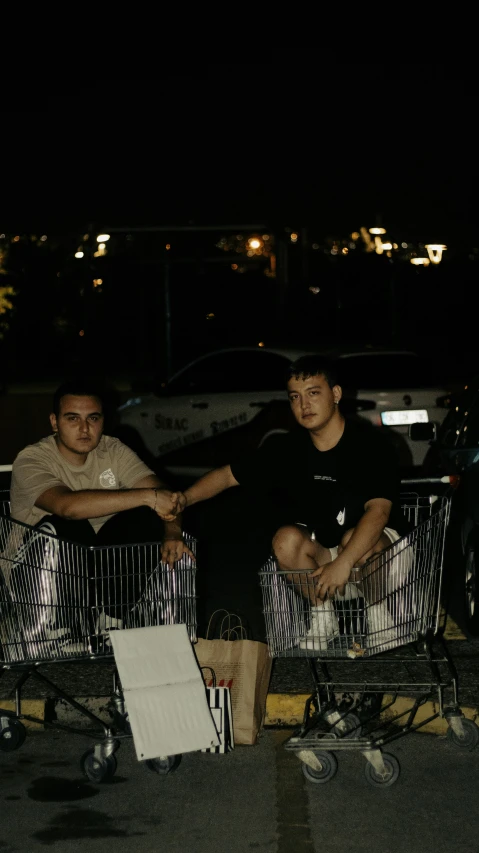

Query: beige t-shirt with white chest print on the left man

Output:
[10, 435, 154, 533]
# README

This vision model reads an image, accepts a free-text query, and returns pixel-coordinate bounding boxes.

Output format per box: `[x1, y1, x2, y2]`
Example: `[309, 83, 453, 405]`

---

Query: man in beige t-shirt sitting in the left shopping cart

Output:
[10, 381, 194, 640]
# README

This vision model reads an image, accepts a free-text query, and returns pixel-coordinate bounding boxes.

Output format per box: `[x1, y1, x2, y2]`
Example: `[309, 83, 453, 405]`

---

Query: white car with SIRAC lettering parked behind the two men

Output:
[116, 346, 450, 475]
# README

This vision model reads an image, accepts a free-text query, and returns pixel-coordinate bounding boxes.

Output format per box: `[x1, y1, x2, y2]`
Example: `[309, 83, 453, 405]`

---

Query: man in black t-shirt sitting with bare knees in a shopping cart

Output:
[176, 356, 404, 648]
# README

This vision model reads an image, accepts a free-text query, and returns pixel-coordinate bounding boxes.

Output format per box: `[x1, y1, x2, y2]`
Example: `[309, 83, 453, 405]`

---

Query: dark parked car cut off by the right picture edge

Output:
[420, 376, 479, 636]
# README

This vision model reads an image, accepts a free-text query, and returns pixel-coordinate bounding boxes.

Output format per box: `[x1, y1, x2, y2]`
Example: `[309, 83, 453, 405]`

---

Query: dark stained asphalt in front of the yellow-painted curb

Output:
[0, 729, 479, 853]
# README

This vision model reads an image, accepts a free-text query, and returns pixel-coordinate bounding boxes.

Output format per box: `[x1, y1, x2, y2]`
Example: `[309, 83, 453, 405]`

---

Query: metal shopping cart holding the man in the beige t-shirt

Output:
[0, 493, 196, 782]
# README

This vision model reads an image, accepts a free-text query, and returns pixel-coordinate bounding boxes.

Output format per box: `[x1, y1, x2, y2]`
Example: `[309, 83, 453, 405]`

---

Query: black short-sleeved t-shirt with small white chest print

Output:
[231, 420, 407, 548]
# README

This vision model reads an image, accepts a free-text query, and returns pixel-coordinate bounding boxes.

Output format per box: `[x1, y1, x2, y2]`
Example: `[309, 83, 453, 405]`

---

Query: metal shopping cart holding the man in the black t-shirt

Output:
[260, 494, 479, 786]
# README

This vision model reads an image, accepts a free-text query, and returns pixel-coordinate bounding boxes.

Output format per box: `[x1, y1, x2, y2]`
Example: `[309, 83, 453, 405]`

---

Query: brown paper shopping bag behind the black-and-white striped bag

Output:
[194, 608, 273, 745]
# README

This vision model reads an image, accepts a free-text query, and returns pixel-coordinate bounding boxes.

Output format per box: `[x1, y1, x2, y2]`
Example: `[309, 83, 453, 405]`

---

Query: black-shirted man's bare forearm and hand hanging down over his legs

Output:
[311, 498, 392, 599]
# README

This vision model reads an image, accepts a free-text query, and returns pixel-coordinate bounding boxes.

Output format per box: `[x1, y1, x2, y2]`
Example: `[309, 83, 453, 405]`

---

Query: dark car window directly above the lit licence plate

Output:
[339, 353, 443, 390]
